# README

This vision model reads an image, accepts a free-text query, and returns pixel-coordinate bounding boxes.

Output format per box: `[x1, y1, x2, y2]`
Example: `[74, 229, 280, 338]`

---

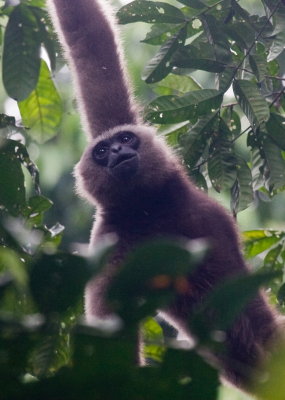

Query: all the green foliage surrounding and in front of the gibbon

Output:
[0, 0, 285, 400]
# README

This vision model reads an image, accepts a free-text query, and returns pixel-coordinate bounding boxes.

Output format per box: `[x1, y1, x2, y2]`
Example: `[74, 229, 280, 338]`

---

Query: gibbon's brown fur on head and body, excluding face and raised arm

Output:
[76, 125, 277, 385]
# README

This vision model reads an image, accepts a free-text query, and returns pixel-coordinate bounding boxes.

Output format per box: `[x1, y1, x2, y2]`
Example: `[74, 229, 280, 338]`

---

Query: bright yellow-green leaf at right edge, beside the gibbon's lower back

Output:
[243, 229, 285, 258]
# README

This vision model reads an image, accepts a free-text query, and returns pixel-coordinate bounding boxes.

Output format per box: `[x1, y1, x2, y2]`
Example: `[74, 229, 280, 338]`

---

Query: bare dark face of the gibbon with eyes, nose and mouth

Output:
[92, 131, 140, 179]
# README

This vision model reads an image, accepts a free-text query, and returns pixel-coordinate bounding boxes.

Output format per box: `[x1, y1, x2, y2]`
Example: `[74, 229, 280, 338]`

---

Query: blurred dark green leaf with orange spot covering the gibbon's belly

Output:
[109, 240, 205, 323]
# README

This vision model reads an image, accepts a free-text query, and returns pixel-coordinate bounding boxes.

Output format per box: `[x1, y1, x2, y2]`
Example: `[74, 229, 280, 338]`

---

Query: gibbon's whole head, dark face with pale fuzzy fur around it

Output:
[75, 125, 177, 205]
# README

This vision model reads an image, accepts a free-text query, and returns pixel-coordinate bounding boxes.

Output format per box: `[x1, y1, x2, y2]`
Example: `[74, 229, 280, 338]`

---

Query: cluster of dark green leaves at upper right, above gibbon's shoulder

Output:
[118, 0, 285, 202]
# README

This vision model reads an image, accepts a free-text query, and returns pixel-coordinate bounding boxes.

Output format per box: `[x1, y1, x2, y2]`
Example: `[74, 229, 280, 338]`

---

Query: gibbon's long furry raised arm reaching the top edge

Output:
[47, 0, 140, 139]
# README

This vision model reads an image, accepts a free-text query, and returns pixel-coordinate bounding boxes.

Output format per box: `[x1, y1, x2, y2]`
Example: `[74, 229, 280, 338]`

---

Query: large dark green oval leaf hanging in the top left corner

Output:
[3, 4, 41, 101]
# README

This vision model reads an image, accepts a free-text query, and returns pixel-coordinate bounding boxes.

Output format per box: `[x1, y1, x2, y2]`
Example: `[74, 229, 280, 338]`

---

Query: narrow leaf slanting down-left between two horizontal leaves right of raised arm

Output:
[143, 27, 186, 83]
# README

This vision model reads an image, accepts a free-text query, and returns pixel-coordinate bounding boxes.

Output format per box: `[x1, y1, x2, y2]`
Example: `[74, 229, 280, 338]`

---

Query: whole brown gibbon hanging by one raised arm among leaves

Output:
[48, 0, 279, 386]
